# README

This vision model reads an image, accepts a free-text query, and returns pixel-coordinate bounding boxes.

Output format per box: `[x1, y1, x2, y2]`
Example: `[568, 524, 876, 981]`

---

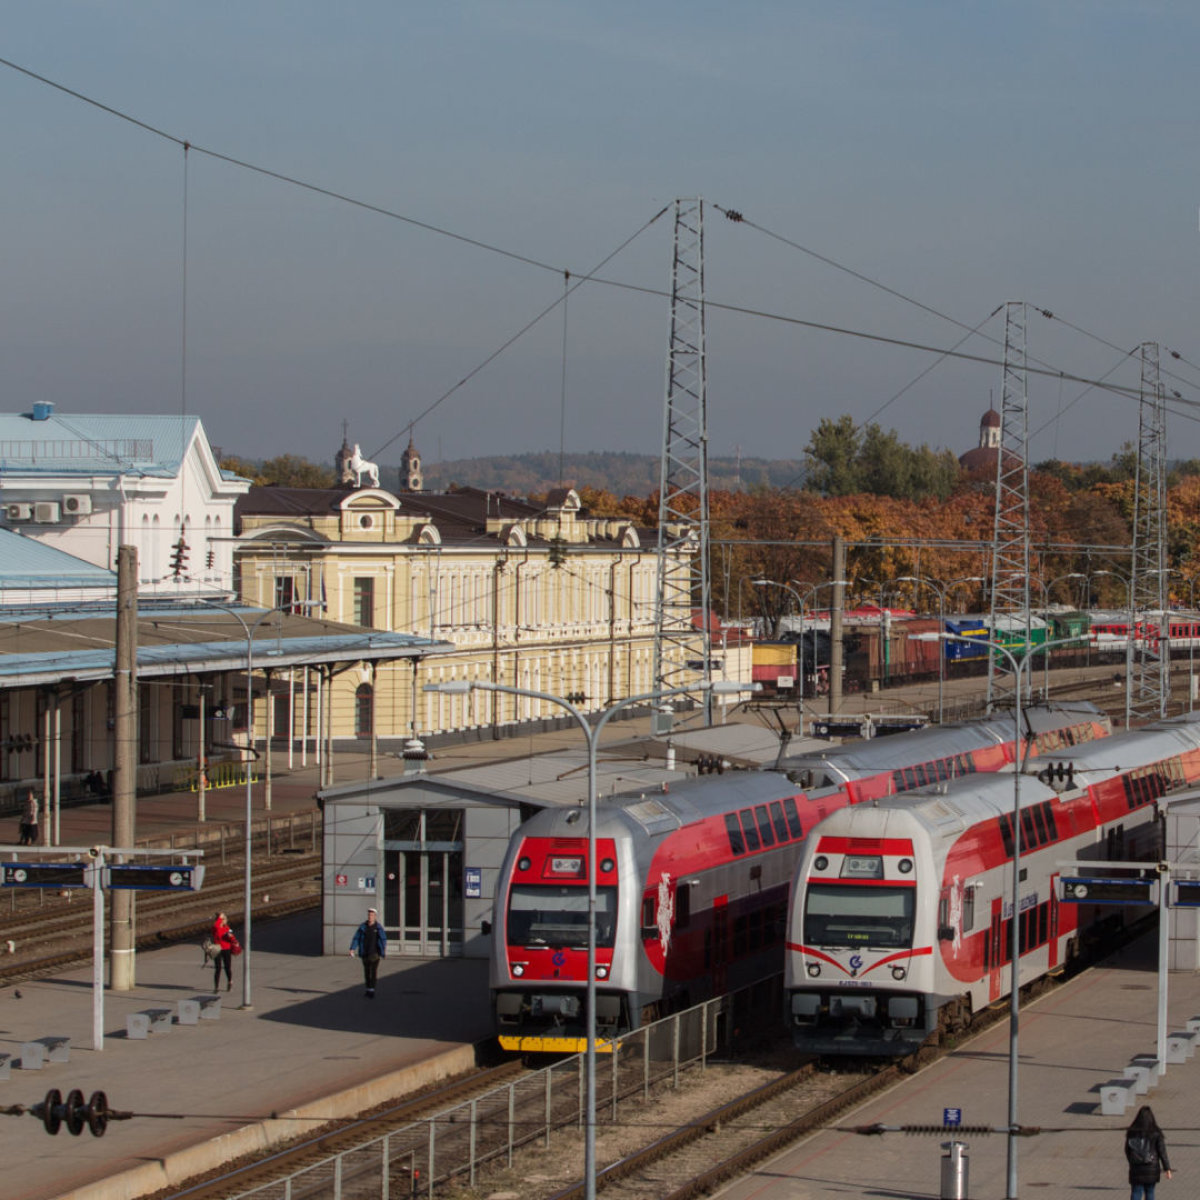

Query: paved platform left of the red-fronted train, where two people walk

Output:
[0, 913, 492, 1200]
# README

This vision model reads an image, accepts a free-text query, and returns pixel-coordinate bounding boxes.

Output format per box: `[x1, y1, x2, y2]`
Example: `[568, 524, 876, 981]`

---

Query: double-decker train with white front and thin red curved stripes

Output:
[785, 715, 1200, 1056]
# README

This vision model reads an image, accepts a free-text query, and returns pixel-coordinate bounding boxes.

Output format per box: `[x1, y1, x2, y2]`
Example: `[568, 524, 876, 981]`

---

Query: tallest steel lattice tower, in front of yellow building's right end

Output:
[653, 199, 713, 732]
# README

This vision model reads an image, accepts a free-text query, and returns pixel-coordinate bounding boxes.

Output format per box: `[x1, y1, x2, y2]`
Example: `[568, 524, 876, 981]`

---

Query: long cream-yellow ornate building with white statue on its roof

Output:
[235, 484, 686, 740]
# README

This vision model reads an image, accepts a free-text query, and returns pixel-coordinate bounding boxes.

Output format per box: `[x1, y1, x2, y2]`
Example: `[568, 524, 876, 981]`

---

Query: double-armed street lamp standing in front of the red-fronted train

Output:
[425, 679, 756, 1200]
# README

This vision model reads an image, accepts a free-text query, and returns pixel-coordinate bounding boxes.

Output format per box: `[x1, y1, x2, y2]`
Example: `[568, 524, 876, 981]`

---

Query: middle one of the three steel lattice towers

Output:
[988, 301, 1030, 713]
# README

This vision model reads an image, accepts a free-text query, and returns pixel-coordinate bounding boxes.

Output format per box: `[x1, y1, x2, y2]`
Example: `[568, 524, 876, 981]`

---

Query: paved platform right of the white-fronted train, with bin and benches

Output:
[720, 935, 1200, 1200]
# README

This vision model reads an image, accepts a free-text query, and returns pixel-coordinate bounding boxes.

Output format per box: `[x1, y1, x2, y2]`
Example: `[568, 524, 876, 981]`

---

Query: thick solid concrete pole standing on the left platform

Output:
[112, 546, 138, 991]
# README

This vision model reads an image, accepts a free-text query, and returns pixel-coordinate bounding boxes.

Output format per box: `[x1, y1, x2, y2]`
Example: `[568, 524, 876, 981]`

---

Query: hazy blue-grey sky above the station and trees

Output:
[0, 0, 1200, 463]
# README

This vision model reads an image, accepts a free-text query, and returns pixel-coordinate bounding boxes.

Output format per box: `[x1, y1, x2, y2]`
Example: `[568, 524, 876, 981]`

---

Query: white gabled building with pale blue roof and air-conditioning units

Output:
[0, 403, 250, 598]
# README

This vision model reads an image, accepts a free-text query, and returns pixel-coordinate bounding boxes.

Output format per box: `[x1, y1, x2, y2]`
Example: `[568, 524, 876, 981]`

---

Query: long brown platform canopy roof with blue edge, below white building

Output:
[0, 602, 454, 689]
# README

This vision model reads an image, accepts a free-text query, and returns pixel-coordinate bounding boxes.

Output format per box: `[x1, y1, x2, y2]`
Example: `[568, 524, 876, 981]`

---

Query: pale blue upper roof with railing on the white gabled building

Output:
[0, 404, 200, 476]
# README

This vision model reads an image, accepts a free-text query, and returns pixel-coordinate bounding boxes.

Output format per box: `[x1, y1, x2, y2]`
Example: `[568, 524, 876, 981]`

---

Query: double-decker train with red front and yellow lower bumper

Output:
[491, 706, 1109, 1052]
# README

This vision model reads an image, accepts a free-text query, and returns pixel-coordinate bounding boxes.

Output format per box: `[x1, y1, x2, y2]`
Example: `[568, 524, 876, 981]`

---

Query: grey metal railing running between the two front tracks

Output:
[230, 976, 781, 1200]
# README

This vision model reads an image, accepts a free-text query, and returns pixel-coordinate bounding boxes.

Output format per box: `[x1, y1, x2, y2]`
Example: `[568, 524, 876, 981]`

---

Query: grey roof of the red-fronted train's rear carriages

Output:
[779, 701, 1108, 779]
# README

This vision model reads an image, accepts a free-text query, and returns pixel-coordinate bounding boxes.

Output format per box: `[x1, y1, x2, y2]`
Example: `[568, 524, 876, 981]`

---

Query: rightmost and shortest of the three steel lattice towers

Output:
[1126, 342, 1171, 726]
